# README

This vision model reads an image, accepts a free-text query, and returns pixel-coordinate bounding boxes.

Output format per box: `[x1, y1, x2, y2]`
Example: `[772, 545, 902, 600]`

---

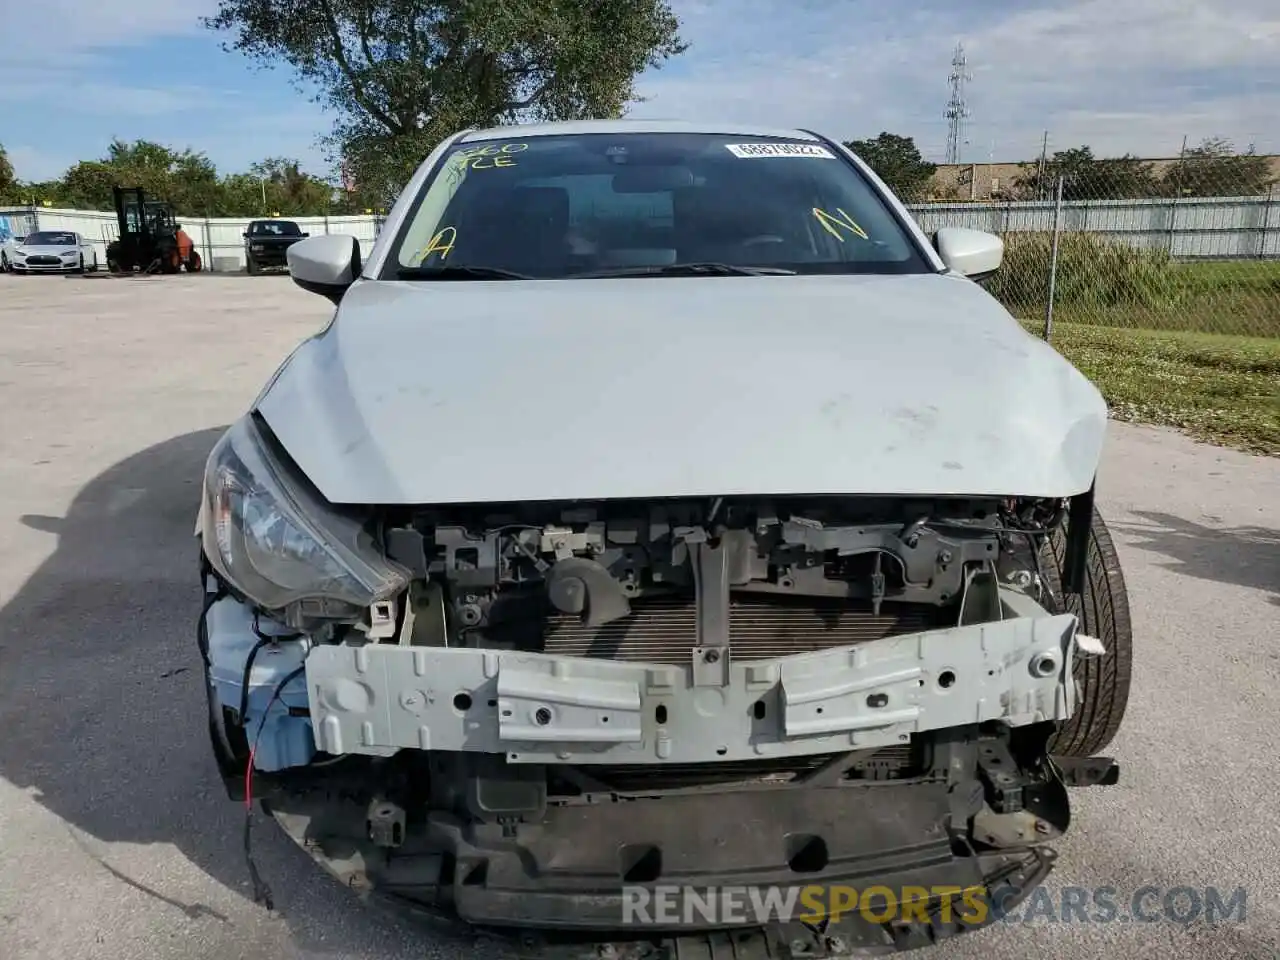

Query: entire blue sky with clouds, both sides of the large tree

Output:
[0, 0, 1280, 179]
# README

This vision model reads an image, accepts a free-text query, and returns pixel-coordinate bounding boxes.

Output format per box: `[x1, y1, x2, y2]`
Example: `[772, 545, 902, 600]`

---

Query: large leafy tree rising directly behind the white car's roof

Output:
[205, 0, 685, 201]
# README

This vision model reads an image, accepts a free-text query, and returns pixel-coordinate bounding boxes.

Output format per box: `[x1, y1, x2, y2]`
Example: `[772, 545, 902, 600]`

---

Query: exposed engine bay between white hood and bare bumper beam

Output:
[370, 497, 1066, 662]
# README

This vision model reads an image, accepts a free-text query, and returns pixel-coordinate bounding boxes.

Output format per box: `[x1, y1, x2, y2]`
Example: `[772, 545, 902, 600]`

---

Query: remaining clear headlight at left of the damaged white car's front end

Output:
[201, 416, 410, 622]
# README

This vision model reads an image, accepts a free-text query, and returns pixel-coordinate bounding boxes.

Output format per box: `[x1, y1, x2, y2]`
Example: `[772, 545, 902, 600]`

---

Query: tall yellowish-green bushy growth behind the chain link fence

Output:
[988, 233, 1183, 312]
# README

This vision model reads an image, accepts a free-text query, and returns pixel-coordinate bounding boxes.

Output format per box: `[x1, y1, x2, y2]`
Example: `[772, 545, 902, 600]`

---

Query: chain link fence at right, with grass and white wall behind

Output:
[911, 157, 1280, 338]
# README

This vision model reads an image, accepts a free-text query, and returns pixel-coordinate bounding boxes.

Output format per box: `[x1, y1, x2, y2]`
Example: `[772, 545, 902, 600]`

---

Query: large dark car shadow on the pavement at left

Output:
[0, 429, 471, 956]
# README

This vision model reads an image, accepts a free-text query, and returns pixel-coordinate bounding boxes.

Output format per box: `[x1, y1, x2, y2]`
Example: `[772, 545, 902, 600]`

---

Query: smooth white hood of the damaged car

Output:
[256, 274, 1106, 504]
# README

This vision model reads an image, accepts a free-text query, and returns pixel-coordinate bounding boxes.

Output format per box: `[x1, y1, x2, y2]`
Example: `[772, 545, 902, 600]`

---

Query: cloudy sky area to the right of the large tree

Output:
[632, 0, 1280, 161]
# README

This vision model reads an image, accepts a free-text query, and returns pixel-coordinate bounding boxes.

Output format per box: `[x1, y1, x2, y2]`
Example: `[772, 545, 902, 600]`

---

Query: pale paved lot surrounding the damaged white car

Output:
[0, 275, 1280, 960]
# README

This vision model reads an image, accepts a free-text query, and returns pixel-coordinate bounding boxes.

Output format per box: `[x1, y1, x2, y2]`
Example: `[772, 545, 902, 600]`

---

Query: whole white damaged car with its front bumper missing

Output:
[197, 122, 1132, 957]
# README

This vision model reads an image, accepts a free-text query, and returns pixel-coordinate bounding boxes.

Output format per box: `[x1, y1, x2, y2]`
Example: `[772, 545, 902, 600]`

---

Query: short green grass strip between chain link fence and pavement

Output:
[1027, 321, 1280, 456]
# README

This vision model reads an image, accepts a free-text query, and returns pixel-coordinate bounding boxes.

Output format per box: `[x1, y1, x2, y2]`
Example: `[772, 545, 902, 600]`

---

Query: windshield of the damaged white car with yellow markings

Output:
[385, 133, 929, 279]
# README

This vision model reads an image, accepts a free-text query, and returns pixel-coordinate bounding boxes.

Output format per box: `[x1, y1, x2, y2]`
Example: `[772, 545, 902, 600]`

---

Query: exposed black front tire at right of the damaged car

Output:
[1041, 507, 1133, 756]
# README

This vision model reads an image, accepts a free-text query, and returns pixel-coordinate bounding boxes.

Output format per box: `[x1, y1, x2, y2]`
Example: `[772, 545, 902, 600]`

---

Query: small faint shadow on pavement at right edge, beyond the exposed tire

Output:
[1115, 511, 1280, 603]
